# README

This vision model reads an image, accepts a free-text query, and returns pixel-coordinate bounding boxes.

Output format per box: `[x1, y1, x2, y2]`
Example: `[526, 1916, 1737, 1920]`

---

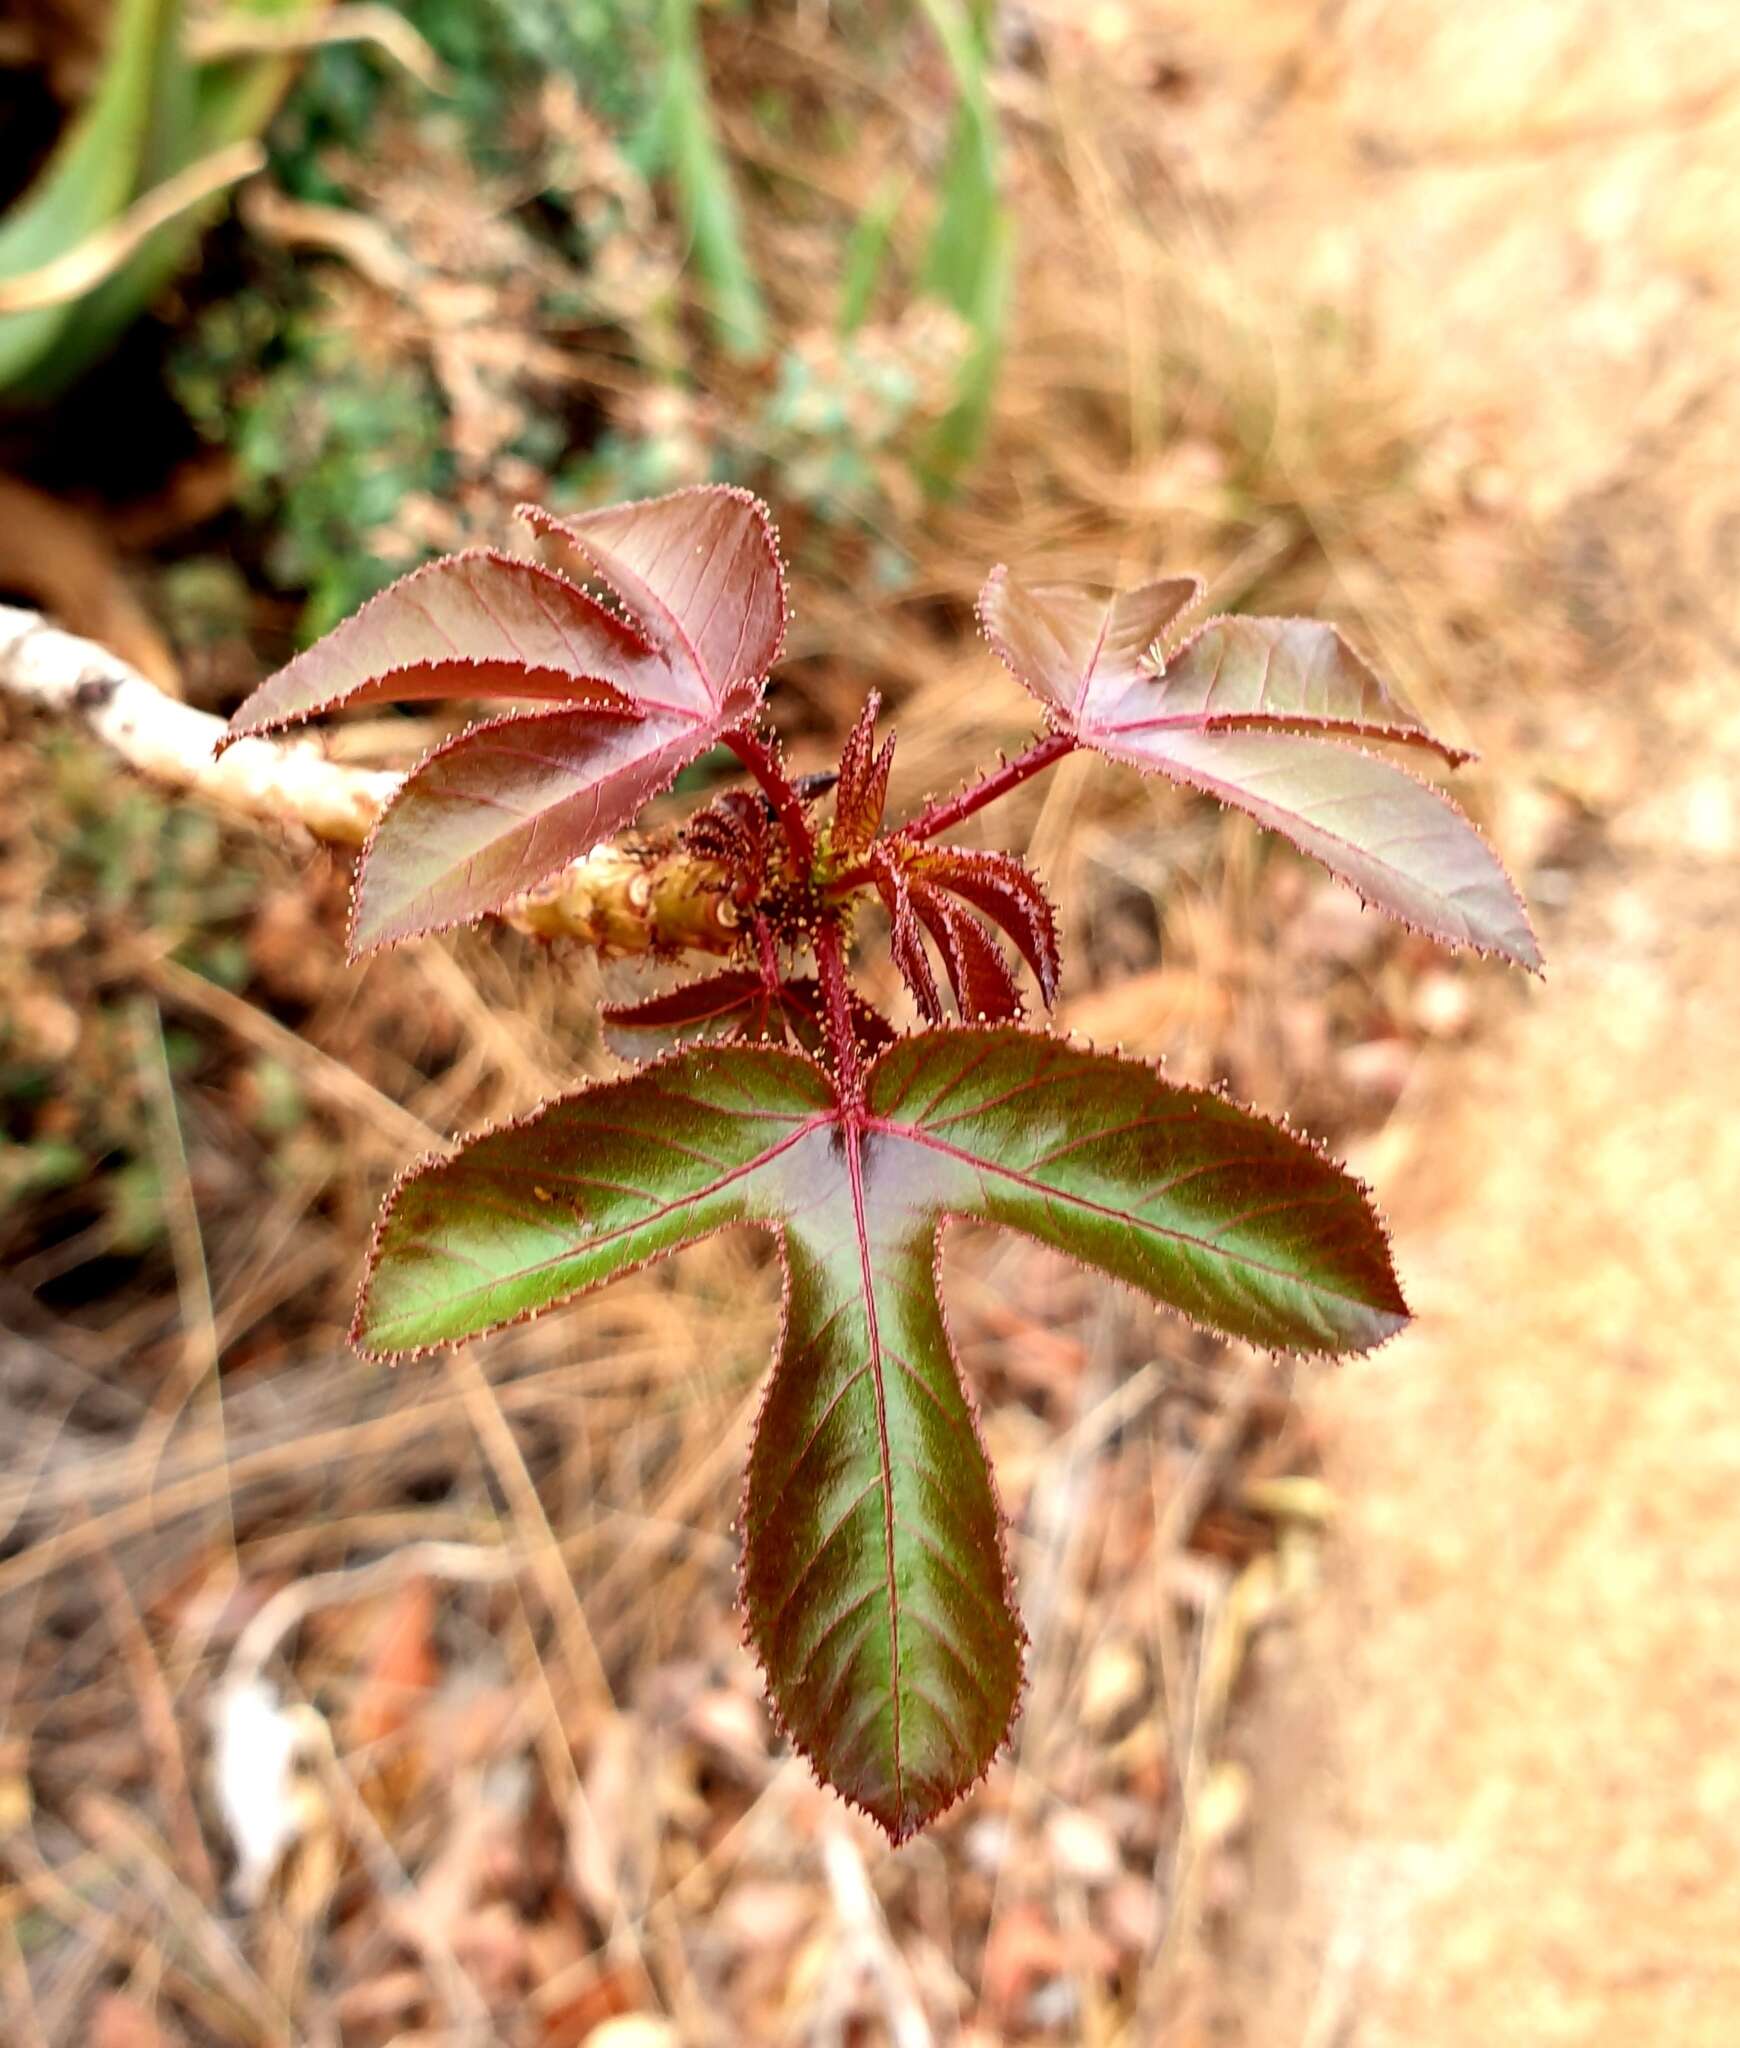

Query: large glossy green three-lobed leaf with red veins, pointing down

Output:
[356, 1026, 1406, 1841]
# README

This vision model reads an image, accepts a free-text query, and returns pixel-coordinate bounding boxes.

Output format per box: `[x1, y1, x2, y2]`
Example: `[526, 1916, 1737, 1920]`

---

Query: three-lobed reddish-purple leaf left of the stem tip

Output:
[227, 487, 786, 952]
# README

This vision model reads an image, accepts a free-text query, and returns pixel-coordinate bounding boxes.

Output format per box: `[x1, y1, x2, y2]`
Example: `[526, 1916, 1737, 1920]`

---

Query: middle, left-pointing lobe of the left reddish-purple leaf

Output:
[219, 549, 663, 748]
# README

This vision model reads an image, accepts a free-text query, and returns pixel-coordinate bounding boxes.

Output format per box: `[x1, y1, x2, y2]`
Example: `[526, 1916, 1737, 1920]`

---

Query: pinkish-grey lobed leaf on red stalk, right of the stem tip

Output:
[978, 569, 1541, 969]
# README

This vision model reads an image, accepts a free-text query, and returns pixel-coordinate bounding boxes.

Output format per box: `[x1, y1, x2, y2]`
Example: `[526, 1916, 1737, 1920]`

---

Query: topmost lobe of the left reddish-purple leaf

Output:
[520, 483, 786, 715]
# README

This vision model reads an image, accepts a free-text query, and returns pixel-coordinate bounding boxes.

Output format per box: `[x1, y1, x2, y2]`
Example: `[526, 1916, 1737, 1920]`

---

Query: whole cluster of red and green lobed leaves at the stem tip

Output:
[216, 489, 1539, 1841]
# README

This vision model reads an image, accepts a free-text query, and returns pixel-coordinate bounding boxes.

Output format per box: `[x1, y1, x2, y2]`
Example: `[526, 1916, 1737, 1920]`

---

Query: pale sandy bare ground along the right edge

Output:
[1203, 8, 1740, 2048]
